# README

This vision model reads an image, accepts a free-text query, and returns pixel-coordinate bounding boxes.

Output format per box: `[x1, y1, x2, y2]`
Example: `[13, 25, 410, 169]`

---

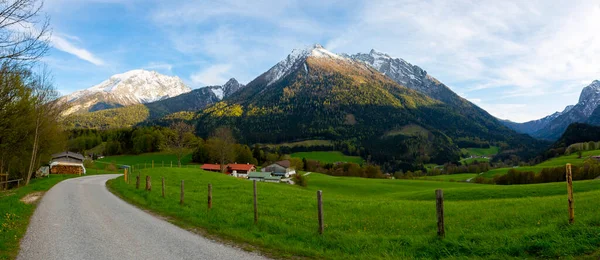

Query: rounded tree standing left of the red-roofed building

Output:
[162, 121, 197, 167]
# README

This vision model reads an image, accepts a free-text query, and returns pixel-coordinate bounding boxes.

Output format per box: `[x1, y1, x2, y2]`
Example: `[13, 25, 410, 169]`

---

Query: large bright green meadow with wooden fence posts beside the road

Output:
[108, 168, 600, 259]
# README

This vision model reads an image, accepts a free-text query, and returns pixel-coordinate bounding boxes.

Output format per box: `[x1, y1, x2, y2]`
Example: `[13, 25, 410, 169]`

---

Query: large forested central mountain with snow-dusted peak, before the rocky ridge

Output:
[197, 45, 539, 171]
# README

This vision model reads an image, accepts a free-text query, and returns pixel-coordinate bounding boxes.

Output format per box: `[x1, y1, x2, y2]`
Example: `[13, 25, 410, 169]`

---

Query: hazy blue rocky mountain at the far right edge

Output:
[503, 80, 600, 140]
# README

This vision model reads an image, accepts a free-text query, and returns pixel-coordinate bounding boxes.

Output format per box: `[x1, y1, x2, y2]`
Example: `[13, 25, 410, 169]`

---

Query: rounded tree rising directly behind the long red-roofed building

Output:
[207, 127, 236, 172]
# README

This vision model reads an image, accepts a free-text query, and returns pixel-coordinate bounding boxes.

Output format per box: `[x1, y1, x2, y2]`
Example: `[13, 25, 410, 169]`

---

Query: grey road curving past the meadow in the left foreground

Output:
[17, 175, 266, 260]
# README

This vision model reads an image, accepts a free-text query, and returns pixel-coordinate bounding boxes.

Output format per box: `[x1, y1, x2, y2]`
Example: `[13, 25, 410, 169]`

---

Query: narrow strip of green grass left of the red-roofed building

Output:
[96, 153, 192, 169]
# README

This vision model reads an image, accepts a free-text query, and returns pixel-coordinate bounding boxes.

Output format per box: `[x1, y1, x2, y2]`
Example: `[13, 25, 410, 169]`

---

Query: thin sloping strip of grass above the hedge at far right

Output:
[482, 150, 600, 178]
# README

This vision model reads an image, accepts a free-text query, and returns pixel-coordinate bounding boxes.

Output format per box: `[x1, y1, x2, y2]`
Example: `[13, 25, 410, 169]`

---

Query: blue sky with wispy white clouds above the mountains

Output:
[39, 0, 600, 122]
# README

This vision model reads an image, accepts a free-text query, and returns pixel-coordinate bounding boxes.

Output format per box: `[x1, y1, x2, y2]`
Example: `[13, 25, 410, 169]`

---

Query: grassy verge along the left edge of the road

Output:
[0, 175, 76, 259]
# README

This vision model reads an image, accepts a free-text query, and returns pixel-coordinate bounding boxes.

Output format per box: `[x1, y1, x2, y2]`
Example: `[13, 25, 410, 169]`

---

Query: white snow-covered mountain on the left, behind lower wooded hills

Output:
[61, 70, 191, 115]
